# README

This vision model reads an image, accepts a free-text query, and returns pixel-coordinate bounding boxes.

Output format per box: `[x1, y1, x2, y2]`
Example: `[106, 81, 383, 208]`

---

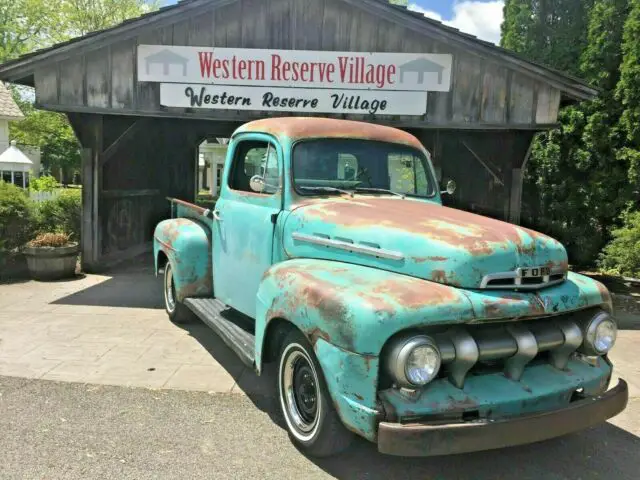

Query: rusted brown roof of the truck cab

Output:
[233, 117, 424, 150]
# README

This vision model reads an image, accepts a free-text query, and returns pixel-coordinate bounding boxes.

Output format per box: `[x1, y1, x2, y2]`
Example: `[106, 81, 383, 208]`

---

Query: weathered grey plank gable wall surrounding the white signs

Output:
[35, 0, 560, 129]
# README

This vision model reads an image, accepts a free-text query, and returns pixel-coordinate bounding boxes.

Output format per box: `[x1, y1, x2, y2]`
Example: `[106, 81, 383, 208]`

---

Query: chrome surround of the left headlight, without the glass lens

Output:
[386, 334, 442, 388]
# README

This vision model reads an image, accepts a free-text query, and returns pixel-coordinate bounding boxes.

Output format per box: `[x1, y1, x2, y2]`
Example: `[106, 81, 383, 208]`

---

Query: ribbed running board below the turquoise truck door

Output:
[184, 298, 256, 367]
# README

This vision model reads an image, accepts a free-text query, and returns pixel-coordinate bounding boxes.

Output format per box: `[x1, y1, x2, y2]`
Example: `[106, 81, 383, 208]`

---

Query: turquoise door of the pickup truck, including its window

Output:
[213, 133, 282, 318]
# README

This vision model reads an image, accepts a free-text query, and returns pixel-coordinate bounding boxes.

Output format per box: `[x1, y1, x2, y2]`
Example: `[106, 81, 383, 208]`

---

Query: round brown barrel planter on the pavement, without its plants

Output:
[24, 243, 78, 280]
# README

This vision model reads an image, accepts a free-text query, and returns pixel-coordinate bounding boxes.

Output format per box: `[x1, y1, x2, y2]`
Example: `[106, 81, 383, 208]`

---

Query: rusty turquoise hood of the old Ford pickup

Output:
[283, 196, 567, 288]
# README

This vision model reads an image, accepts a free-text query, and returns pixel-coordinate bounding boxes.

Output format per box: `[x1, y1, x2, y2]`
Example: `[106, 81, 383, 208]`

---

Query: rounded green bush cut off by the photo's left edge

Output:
[0, 181, 33, 255]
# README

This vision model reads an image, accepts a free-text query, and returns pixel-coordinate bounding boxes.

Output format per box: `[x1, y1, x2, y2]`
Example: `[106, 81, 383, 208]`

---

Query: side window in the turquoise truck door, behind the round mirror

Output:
[229, 141, 280, 195]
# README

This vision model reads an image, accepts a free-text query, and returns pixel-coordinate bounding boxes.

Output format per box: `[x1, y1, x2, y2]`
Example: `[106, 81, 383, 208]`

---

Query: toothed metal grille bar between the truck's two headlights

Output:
[432, 312, 584, 388]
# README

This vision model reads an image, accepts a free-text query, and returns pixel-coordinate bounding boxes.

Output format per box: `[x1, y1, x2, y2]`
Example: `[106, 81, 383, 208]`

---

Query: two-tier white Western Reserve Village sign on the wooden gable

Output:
[138, 45, 452, 115]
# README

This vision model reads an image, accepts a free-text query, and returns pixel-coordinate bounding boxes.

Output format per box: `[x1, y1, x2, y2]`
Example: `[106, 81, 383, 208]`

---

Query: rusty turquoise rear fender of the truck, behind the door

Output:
[153, 218, 213, 302]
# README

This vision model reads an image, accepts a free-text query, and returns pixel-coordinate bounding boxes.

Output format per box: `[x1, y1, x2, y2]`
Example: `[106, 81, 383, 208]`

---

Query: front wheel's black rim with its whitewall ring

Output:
[282, 351, 318, 433]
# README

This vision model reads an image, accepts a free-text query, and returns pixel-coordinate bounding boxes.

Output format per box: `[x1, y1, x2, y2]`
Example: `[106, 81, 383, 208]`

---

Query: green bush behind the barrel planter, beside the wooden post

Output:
[35, 189, 82, 242]
